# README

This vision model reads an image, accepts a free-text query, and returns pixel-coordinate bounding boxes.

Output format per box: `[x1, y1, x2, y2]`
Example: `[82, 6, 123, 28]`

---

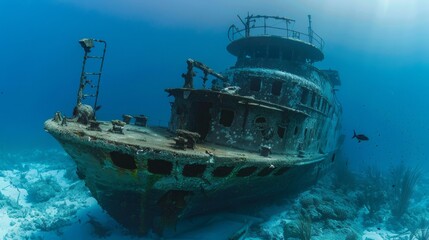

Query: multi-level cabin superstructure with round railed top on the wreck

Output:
[166, 15, 339, 158]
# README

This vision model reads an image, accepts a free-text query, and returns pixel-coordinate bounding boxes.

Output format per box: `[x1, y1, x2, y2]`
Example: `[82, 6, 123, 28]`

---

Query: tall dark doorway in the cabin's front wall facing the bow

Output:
[189, 102, 212, 140]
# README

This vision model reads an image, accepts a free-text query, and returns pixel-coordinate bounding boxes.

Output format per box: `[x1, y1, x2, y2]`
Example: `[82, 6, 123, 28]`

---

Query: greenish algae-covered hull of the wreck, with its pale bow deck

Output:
[45, 120, 332, 234]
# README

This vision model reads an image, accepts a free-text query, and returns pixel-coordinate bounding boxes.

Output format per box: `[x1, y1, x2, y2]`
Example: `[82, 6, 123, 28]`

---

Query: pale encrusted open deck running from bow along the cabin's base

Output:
[45, 120, 327, 166]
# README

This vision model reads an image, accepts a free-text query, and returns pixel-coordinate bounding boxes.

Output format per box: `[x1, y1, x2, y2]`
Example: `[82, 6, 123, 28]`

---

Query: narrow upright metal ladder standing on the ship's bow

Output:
[76, 38, 107, 120]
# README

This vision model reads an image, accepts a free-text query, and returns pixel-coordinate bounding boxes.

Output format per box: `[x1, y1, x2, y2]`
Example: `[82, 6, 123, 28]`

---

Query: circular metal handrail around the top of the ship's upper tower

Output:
[228, 15, 325, 50]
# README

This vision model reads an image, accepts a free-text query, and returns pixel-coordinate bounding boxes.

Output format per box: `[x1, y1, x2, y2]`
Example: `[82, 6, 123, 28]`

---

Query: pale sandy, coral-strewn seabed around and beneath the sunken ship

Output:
[0, 149, 429, 240]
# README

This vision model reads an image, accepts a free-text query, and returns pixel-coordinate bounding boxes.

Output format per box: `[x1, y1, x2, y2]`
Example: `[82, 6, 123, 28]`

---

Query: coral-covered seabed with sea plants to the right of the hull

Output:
[241, 158, 429, 240]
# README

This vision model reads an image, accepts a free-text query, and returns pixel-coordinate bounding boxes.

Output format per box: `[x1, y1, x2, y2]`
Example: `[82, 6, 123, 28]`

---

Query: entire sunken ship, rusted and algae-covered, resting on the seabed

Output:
[44, 15, 342, 234]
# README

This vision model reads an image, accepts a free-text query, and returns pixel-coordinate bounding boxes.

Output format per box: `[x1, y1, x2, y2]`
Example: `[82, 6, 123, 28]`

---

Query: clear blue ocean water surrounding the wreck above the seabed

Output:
[0, 0, 429, 238]
